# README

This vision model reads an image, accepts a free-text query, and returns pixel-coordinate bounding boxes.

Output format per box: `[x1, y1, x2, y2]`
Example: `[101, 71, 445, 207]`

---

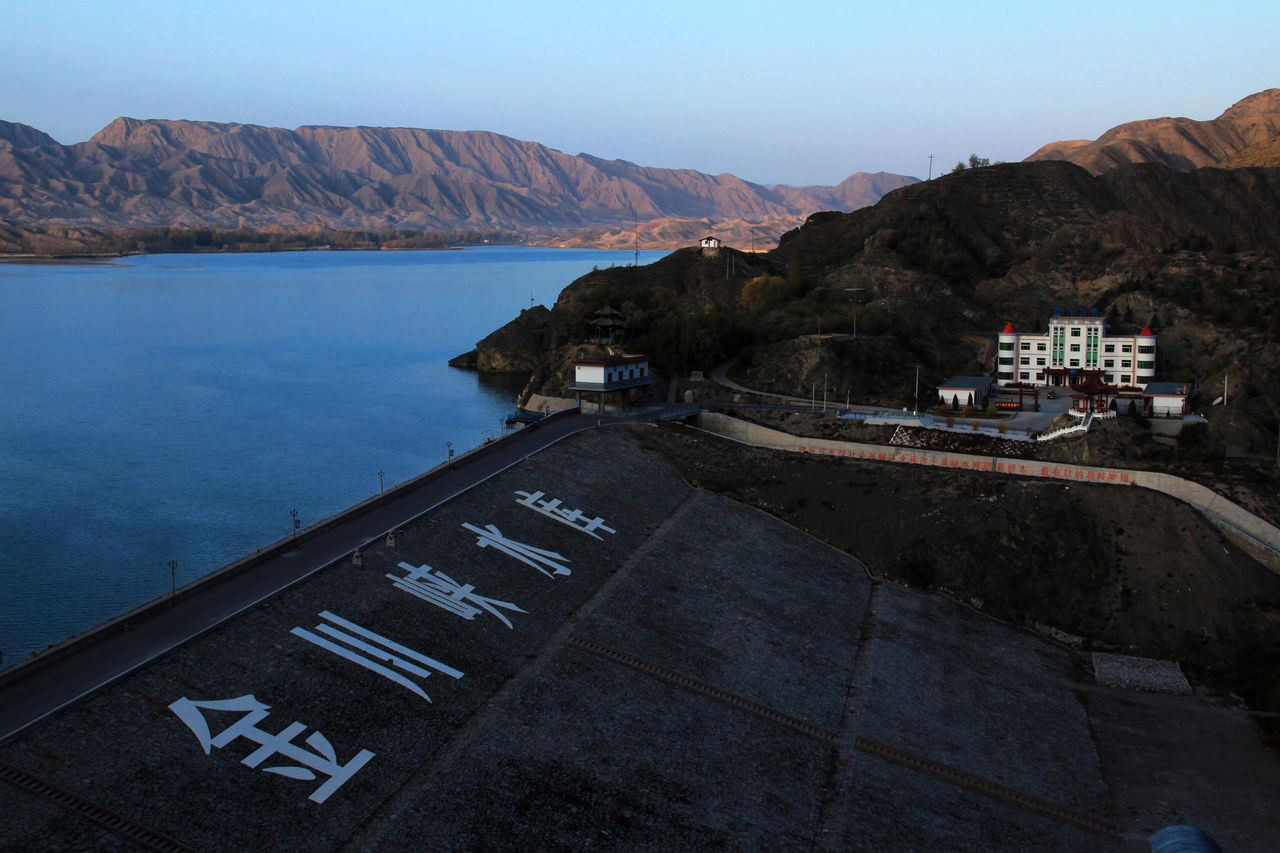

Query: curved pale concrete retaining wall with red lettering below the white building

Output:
[696, 411, 1280, 558]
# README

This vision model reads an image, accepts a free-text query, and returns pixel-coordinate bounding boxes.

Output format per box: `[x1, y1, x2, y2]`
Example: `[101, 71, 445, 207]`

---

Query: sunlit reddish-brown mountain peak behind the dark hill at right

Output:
[1027, 88, 1280, 174]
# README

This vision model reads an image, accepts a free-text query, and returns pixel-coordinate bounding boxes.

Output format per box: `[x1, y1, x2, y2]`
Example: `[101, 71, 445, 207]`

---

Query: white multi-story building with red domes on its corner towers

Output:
[996, 309, 1156, 388]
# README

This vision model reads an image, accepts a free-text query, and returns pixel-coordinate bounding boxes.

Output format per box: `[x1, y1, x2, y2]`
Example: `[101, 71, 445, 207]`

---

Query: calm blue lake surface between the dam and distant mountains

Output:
[0, 247, 662, 666]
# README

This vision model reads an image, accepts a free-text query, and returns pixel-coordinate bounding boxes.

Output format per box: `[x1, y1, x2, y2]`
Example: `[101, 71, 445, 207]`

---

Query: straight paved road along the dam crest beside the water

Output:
[0, 415, 639, 742]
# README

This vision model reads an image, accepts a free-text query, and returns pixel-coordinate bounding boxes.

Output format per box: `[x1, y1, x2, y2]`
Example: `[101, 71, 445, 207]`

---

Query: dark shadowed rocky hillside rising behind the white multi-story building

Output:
[478, 161, 1280, 455]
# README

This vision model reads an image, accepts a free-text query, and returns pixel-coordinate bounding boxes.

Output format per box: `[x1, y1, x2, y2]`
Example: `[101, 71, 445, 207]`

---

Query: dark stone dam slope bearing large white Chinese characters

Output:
[0, 416, 1274, 850]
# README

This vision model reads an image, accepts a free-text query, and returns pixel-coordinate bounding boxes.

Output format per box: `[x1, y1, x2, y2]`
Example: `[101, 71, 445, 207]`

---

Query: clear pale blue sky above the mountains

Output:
[0, 0, 1280, 184]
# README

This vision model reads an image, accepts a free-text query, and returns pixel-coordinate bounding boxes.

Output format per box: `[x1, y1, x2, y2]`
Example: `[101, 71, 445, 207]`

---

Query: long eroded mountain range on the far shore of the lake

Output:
[0, 118, 915, 245]
